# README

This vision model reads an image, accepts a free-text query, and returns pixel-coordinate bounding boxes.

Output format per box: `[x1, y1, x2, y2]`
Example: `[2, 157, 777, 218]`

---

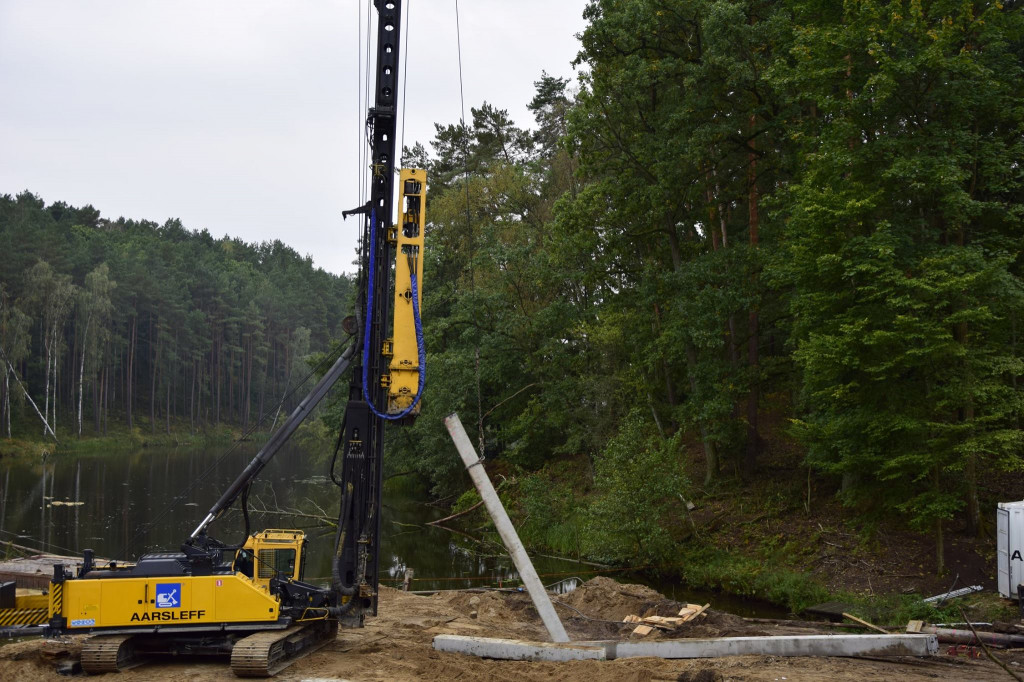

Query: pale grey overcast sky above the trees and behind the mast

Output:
[0, 0, 587, 272]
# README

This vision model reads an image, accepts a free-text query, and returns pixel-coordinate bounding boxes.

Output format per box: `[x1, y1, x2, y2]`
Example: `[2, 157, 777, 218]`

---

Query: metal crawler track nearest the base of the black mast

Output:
[231, 621, 338, 677]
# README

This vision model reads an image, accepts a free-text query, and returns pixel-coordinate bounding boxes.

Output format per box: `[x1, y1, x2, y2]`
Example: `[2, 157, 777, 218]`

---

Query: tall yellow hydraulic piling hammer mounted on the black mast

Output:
[382, 168, 427, 416]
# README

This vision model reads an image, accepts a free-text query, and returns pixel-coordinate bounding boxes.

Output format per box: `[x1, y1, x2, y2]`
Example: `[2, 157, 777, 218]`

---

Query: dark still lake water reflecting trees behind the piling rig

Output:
[0, 443, 783, 617]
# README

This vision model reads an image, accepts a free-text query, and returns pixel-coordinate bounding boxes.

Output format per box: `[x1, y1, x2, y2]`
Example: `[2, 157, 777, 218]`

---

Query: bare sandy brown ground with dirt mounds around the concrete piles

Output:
[0, 578, 1024, 682]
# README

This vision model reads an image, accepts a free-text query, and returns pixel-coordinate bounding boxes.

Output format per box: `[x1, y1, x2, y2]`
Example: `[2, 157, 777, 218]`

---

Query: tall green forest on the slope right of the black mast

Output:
[390, 0, 1024, 570]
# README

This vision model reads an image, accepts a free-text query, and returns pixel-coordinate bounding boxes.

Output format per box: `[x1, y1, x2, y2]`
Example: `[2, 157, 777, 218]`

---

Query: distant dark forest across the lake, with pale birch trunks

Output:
[0, 191, 351, 438]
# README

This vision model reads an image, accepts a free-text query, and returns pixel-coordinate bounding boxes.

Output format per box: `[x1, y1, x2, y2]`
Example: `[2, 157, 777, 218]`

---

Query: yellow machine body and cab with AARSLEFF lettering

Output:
[49, 529, 305, 632]
